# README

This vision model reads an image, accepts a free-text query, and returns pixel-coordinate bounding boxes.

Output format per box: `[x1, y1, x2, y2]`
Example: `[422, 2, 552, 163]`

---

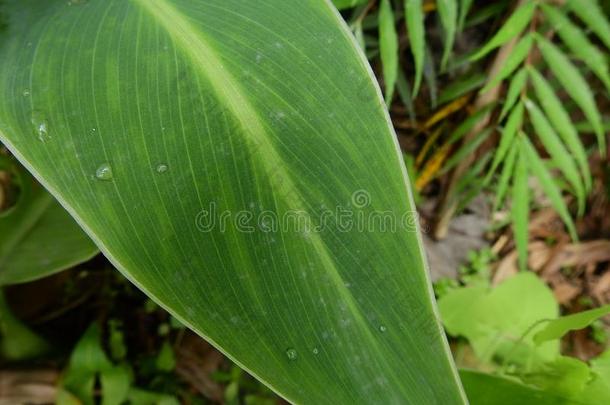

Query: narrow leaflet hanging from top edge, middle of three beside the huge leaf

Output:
[405, 0, 426, 97]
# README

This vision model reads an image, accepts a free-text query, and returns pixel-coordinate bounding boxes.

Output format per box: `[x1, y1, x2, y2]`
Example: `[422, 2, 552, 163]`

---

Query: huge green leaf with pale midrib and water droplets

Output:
[0, 0, 464, 404]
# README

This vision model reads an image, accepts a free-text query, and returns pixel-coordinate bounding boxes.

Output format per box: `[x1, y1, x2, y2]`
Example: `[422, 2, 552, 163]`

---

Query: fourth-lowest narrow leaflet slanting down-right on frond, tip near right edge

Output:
[536, 36, 606, 155]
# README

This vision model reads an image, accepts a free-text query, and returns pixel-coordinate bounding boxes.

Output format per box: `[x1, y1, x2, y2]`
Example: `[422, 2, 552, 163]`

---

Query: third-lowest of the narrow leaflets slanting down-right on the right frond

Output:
[529, 68, 592, 190]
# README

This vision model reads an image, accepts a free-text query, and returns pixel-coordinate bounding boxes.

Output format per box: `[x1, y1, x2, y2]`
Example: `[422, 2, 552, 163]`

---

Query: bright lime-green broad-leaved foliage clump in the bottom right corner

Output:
[439, 272, 610, 405]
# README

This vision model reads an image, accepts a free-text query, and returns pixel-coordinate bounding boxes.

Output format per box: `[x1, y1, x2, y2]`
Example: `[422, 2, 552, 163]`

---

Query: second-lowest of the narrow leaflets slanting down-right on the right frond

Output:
[525, 100, 586, 215]
